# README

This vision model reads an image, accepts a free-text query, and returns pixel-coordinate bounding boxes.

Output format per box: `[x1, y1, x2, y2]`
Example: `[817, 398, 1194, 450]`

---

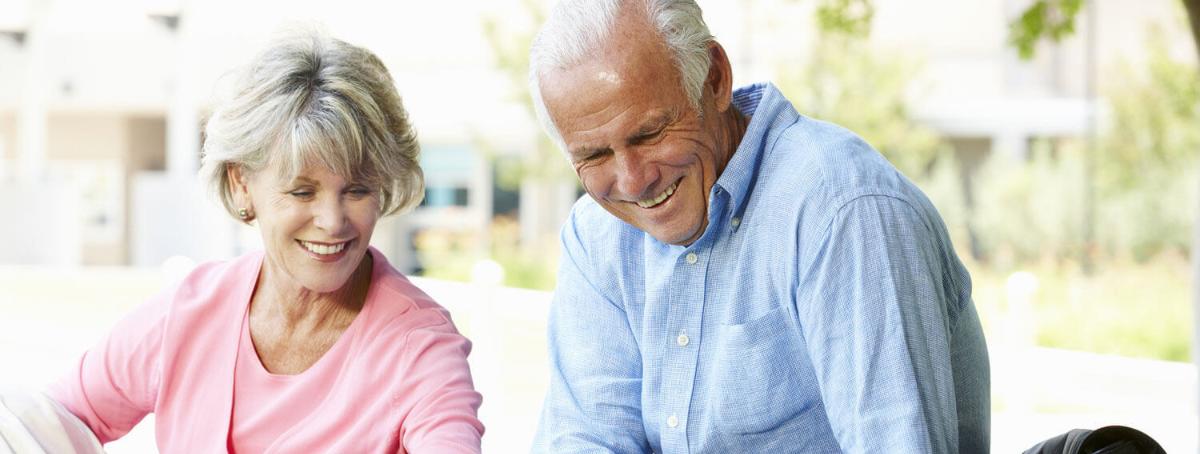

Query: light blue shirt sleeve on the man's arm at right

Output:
[797, 196, 959, 453]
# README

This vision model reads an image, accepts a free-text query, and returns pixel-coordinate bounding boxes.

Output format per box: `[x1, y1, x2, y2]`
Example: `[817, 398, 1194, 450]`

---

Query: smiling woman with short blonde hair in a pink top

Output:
[42, 34, 484, 453]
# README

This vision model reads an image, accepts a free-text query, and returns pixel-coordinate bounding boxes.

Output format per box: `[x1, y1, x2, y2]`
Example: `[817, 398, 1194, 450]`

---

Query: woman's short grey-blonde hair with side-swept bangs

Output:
[200, 31, 425, 219]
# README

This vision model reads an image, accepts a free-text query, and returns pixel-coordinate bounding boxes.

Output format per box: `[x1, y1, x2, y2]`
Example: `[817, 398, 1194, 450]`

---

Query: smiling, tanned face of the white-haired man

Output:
[540, 19, 732, 245]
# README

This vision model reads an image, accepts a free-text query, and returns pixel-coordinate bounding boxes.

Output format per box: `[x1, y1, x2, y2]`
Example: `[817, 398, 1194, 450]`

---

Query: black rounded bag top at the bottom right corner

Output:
[1025, 425, 1166, 454]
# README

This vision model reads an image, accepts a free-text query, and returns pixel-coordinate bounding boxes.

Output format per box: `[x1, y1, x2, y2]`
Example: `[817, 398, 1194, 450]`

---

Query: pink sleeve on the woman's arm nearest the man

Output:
[401, 322, 484, 454]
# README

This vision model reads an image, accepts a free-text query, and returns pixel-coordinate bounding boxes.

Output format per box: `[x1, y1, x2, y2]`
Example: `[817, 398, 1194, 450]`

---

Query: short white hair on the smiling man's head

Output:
[529, 0, 713, 151]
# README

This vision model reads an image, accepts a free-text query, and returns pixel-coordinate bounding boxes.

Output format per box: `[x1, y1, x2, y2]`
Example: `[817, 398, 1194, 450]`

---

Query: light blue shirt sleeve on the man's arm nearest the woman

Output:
[533, 215, 650, 453]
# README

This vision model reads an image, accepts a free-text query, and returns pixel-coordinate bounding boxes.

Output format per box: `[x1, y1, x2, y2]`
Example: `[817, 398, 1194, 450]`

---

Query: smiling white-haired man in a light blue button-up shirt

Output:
[530, 0, 990, 453]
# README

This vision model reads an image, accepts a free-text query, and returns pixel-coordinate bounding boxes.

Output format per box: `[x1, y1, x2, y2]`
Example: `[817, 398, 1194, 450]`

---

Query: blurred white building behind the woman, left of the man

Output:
[0, 0, 535, 269]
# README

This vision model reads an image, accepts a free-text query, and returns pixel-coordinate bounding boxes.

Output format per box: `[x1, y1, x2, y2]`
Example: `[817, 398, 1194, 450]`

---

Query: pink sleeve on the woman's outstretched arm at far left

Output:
[47, 292, 170, 443]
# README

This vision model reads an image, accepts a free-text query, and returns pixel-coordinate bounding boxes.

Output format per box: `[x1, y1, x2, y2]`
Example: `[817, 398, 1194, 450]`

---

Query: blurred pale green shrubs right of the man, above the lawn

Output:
[918, 39, 1200, 265]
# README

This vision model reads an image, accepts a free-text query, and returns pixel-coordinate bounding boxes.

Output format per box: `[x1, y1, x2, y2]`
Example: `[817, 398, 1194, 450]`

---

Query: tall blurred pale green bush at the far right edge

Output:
[1096, 38, 1200, 261]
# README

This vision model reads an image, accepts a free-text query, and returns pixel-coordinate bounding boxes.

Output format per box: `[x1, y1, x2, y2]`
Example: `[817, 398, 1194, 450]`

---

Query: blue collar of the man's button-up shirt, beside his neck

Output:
[715, 83, 791, 223]
